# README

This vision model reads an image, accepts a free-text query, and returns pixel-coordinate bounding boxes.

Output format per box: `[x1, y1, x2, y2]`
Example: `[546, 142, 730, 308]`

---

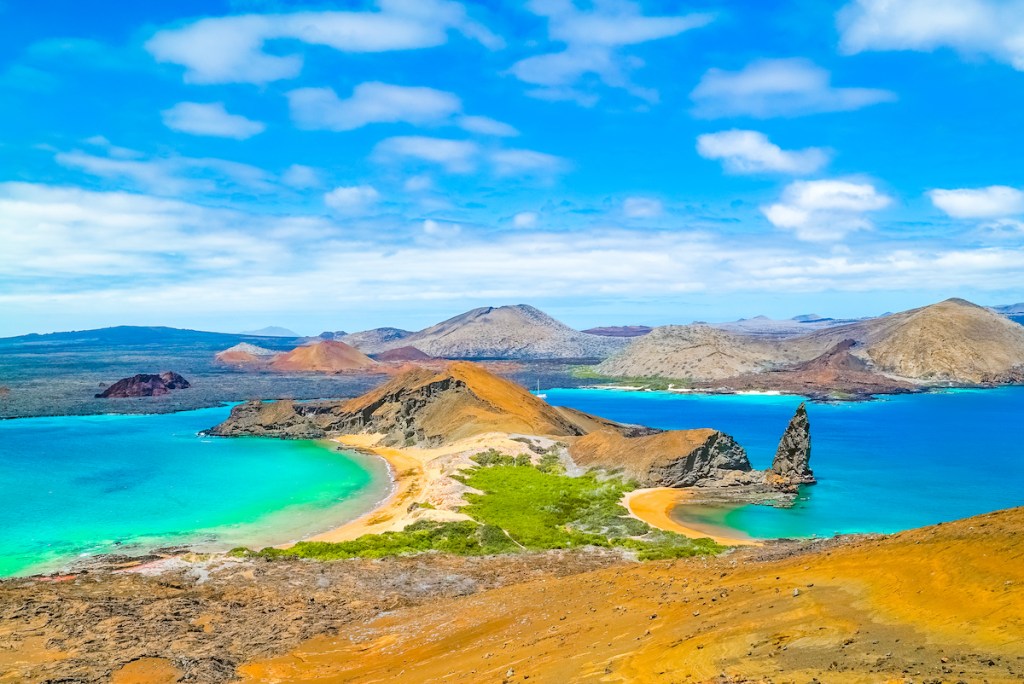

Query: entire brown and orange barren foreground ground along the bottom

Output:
[0, 509, 1024, 684]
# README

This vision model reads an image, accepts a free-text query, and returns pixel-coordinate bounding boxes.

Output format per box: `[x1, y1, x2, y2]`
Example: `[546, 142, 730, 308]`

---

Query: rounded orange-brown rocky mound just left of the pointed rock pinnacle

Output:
[569, 429, 758, 487]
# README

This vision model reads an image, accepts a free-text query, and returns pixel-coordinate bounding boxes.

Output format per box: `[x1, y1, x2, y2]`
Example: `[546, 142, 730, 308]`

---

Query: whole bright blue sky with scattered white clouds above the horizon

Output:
[0, 0, 1024, 335]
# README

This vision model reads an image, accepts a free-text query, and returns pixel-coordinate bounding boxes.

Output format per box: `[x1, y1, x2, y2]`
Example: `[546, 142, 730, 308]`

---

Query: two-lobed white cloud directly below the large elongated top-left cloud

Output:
[288, 82, 462, 131]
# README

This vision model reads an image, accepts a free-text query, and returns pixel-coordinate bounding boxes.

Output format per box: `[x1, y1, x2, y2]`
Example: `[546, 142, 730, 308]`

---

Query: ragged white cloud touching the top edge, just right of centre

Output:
[510, 0, 713, 105]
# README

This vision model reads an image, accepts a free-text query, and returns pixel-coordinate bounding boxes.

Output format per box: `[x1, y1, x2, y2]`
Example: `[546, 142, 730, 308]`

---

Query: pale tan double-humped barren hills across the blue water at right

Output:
[597, 299, 1024, 390]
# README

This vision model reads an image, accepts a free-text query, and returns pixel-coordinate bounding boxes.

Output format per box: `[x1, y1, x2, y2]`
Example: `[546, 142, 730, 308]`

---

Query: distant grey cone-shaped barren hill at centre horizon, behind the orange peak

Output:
[368, 304, 628, 358]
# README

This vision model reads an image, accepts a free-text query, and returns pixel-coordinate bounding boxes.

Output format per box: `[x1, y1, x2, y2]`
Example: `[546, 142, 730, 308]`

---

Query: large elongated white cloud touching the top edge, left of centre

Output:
[145, 0, 502, 83]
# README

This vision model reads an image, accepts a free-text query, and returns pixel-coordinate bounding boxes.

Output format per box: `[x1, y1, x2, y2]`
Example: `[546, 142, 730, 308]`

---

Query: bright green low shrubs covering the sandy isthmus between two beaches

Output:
[232, 448, 723, 560]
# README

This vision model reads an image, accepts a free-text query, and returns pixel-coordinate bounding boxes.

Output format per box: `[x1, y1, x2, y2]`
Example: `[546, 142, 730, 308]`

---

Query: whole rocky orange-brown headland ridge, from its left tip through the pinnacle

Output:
[209, 361, 810, 490]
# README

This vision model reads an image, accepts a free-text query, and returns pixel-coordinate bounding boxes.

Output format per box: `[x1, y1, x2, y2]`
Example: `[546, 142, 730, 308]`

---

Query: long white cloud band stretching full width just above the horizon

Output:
[9, 183, 1024, 334]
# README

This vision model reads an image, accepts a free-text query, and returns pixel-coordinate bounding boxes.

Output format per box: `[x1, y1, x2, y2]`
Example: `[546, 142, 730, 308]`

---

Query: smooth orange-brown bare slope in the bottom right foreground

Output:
[240, 509, 1024, 684]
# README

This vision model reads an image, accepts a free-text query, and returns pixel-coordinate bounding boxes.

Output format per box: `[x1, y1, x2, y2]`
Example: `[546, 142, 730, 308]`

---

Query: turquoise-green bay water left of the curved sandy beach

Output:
[0, 408, 390, 576]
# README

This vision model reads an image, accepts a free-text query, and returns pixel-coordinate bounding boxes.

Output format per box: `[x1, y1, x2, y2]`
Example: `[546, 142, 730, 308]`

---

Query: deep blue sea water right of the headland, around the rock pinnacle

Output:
[546, 387, 1024, 538]
